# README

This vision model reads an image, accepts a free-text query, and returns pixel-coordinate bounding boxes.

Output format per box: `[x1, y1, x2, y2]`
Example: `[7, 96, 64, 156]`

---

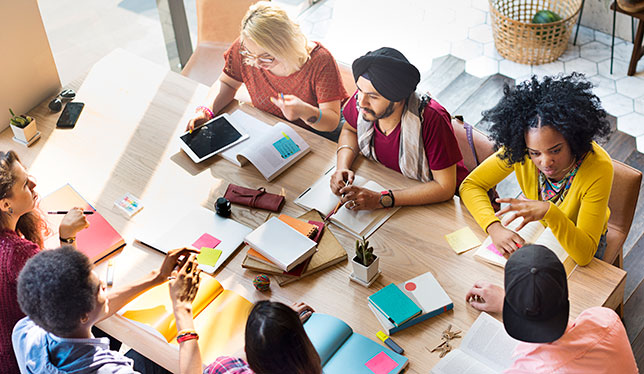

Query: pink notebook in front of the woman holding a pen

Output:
[40, 184, 125, 262]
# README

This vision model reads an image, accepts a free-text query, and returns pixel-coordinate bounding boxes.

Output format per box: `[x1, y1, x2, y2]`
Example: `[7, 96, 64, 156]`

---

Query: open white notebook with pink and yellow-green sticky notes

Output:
[136, 207, 253, 274]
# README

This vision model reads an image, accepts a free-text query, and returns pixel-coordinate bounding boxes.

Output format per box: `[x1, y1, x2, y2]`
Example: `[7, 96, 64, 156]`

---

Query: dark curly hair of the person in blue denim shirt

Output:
[18, 247, 97, 336]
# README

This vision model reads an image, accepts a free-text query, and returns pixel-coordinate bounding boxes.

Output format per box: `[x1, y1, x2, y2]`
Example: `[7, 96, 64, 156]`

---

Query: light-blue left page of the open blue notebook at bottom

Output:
[304, 313, 353, 366]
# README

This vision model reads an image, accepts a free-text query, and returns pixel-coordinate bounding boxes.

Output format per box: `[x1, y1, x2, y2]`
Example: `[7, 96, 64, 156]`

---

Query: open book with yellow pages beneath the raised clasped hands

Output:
[118, 274, 253, 362]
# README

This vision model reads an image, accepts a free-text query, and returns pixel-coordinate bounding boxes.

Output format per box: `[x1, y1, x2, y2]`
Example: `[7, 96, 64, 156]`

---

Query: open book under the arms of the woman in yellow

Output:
[474, 218, 577, 275]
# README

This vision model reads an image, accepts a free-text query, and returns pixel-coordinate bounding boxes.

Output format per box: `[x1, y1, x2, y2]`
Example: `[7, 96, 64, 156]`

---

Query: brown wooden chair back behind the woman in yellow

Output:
[604, 160, 642, 269]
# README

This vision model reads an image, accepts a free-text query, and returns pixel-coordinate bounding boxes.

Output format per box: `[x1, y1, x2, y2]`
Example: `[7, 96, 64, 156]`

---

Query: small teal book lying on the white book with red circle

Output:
[368, 283, 422, 326]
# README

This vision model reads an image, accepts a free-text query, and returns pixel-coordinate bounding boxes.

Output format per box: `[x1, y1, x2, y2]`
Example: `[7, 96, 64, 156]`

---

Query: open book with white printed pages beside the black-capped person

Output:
[431, 313, 518, 374]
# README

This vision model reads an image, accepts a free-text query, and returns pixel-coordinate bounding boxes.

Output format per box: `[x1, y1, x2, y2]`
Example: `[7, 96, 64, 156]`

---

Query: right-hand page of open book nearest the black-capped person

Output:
[460, 312, 518, 372]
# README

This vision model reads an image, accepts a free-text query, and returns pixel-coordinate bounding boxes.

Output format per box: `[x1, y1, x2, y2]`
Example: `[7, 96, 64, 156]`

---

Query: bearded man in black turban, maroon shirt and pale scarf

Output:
[331, 47, 467, 210]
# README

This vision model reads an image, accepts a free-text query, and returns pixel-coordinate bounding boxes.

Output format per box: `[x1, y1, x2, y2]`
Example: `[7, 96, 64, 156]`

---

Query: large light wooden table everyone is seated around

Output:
[0, 50, 626, 373]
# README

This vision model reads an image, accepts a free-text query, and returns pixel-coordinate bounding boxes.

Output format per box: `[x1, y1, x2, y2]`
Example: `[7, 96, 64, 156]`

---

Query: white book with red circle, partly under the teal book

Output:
[368, 272, 454, 335]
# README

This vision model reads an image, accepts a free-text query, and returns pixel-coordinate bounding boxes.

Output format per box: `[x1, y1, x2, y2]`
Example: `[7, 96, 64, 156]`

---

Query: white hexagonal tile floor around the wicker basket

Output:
[298, 0, 644, 152]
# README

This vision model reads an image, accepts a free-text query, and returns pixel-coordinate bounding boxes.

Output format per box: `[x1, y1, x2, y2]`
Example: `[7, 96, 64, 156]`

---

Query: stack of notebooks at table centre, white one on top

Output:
[242, 211, 347, 286]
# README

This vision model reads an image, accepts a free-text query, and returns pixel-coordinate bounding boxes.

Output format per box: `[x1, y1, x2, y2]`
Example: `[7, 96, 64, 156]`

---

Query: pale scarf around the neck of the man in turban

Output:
[356, 92, 433, 182]
